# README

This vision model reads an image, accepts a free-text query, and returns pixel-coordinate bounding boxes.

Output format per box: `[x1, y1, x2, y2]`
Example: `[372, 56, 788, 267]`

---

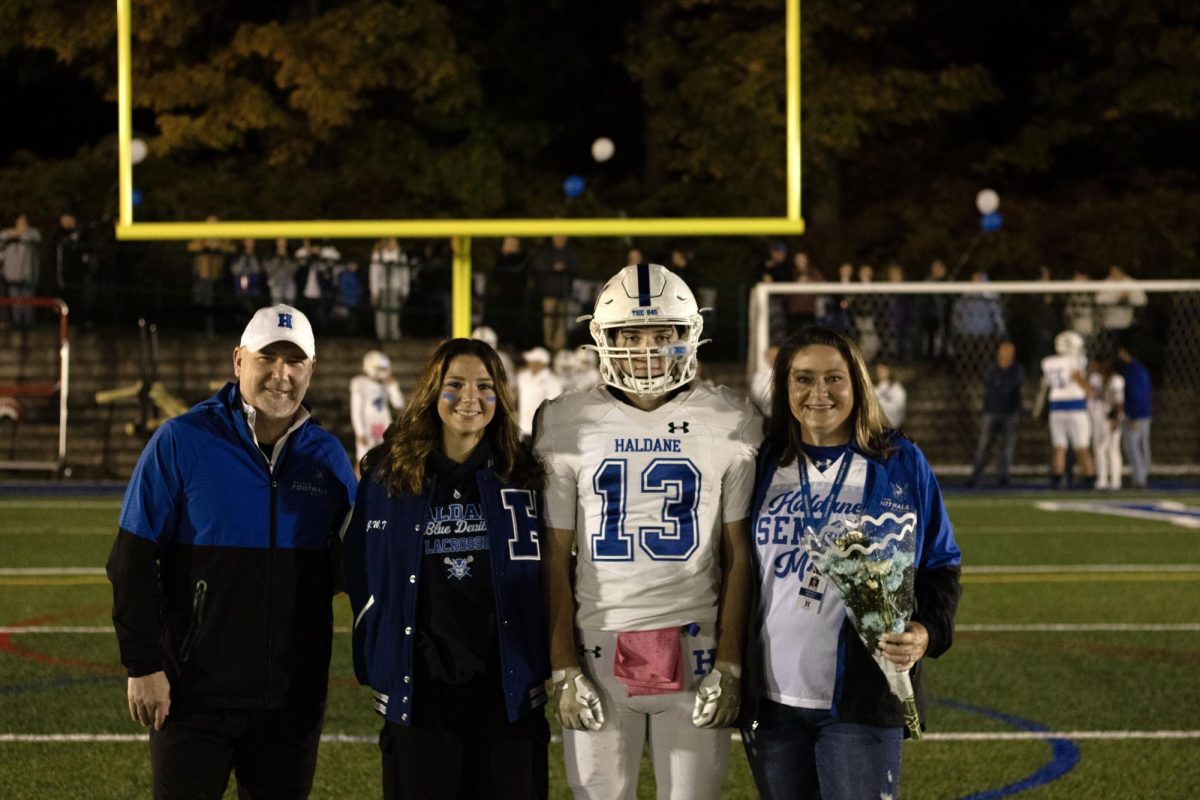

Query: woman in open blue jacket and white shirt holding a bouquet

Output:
[743, 326, 960, 800]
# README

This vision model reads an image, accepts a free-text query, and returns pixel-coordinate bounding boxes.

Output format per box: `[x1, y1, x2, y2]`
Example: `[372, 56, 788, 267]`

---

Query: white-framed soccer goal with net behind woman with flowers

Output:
[746, 281, 1200, 475]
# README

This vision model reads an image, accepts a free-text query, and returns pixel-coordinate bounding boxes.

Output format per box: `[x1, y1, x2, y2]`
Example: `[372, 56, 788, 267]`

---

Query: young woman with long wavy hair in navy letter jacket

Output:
[344, 338, 550, 800]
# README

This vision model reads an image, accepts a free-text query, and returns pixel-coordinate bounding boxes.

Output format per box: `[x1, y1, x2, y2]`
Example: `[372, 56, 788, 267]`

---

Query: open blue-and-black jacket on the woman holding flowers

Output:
[742, 433, 961, 735]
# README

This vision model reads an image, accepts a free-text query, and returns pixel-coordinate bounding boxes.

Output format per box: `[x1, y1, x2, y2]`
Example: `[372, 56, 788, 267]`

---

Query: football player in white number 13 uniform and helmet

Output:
[535, 264, 762, 800]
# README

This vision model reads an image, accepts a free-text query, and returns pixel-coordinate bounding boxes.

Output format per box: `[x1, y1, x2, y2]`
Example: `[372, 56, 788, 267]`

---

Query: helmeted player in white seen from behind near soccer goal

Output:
[1033, 331, 1096, 488]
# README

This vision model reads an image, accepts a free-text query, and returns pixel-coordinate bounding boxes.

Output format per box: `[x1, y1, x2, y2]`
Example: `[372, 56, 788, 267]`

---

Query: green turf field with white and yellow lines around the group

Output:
[0, 492, 1200, 800]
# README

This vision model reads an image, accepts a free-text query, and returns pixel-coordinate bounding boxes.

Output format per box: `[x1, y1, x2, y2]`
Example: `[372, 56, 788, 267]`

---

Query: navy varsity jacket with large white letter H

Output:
[342, 467, 550, 726]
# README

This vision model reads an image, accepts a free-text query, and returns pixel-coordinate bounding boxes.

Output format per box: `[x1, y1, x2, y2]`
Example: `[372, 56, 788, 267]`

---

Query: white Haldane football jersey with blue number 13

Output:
[535, 381, 762, 631]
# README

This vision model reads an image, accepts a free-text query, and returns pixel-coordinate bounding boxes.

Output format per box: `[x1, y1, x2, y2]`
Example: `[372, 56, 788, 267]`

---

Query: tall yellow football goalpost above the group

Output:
[116, 0, 804, 336]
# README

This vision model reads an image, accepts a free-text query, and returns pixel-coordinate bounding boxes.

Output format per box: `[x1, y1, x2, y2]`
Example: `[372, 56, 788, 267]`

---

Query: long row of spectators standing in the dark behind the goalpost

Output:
[0, 213, 1147, 368]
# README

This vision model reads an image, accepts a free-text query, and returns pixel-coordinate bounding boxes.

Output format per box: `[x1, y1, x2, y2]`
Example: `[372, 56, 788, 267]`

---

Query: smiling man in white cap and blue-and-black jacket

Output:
[108, 305, 356, 799]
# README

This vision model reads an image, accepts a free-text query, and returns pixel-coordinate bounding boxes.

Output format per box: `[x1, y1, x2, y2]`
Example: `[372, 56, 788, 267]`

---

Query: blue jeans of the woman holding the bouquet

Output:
[742, 698, 904, 800]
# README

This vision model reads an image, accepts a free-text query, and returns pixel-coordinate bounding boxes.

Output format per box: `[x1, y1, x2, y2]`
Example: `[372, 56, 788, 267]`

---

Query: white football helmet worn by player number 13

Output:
[580, 264, 707, 397]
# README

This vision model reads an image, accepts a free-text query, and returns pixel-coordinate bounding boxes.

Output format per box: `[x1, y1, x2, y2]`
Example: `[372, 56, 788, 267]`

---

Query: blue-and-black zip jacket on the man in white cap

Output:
[108, 384, 356, 709]
